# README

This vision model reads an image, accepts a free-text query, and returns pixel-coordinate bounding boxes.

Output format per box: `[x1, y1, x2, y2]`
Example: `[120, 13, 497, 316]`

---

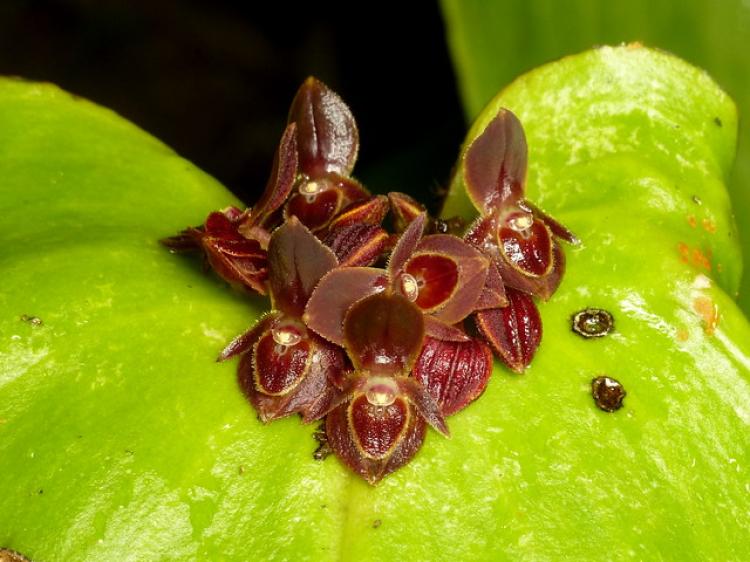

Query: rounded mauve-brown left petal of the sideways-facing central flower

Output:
[303, 267, 388, 345]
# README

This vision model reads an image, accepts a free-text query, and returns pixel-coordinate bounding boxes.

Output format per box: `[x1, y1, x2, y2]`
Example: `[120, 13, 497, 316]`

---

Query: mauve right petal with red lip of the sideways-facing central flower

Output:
[414, 234, 489, 324]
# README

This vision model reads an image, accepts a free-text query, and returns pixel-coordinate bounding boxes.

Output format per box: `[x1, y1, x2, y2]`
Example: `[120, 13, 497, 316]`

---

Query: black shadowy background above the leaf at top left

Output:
[0, 0, 465, 204]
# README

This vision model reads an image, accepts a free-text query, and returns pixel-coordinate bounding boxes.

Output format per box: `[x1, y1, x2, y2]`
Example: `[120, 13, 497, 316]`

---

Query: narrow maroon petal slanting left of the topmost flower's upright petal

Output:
[240, 123, 298, 228]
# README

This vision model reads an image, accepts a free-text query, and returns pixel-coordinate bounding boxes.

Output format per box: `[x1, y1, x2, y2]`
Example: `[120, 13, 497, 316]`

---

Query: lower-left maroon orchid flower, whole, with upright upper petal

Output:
[219, 217, 347, 422]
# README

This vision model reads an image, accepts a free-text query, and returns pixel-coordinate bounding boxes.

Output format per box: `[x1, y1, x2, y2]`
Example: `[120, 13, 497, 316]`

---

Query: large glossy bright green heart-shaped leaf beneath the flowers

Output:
[0, 48, 750, 561]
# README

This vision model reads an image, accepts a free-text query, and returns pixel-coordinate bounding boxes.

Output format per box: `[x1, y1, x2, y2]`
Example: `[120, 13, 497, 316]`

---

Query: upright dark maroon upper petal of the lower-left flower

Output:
[268, 217, 336, 317]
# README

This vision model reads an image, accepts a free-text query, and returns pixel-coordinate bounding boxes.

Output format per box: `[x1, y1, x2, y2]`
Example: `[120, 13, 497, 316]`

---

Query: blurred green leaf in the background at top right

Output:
[441, 0, 750, 314]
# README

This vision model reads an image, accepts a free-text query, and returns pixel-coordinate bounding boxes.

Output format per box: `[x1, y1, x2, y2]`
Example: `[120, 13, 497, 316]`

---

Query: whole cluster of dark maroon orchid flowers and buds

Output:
[163, 78, 576, 484]
